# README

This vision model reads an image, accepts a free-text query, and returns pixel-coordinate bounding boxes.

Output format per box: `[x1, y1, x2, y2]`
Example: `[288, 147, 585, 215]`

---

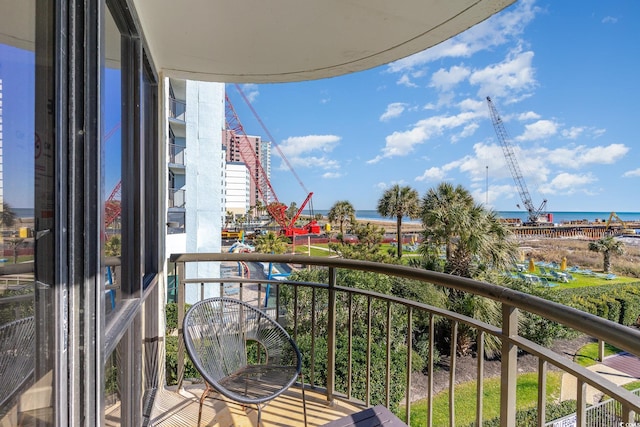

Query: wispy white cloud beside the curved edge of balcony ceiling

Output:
[387, 0, 539, 73]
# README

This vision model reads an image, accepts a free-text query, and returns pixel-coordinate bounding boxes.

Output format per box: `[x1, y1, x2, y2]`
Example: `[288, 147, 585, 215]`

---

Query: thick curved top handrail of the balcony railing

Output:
[170, 253, 640, 355]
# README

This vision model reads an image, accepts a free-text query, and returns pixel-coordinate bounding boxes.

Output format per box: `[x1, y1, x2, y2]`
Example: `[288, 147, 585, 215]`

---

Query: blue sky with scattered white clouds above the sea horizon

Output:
[227, 0, 640, 212]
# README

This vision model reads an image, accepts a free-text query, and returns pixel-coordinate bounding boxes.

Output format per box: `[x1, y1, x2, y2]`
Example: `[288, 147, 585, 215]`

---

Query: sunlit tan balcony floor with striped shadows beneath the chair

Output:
[144, 386, 364, 427]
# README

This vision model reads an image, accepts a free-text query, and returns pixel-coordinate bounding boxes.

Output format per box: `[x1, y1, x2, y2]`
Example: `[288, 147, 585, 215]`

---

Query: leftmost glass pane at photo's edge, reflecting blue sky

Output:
[0, 0, 41, 425]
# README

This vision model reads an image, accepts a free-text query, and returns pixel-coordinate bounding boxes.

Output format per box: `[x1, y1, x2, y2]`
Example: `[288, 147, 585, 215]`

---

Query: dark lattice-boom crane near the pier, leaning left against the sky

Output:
[487, 96, 549, 225]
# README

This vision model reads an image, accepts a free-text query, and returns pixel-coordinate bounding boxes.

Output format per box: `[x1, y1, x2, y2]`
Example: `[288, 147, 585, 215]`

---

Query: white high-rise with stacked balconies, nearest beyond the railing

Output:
[165, 78, 225, 302]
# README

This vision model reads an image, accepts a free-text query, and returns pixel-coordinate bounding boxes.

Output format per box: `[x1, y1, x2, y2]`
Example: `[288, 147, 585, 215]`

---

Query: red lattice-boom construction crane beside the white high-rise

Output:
[225, 92, 320, 237]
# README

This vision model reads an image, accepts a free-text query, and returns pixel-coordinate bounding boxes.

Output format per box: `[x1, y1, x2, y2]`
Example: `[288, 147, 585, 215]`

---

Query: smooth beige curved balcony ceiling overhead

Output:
[133, 0, 515, 83]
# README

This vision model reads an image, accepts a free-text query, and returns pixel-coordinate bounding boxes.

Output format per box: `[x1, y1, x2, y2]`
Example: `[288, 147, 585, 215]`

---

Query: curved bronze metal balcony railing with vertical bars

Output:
[170, 253, 640, 426]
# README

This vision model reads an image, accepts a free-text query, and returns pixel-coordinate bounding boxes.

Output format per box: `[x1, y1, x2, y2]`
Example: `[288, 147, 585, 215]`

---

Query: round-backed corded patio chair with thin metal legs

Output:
[184, 297, 307, 425]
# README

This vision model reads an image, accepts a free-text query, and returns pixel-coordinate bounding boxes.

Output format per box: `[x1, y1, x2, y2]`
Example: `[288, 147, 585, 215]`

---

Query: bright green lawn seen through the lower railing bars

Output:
[400, 372, 561, 426]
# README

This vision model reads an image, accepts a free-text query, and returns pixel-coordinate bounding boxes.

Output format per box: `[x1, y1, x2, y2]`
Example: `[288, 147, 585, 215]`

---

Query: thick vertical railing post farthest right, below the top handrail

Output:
[500, 304, 518, 427]
